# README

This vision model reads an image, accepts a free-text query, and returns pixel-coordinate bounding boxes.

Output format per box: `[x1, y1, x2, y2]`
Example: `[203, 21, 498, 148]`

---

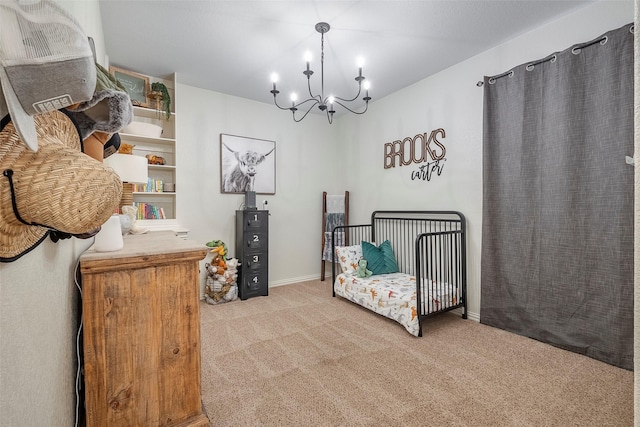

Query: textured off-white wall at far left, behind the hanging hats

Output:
[0, 0, 104, 427]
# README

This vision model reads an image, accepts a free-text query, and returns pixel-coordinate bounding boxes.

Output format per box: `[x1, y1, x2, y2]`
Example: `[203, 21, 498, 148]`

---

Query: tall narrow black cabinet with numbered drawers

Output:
[236, 209, 269, 300]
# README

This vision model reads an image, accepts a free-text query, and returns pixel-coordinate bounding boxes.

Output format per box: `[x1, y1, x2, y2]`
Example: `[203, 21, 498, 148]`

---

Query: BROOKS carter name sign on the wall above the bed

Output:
[384, 128, 447, 181]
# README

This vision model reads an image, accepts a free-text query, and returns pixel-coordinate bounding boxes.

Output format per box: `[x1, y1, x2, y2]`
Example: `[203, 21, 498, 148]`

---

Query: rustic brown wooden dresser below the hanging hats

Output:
[80, 231, 209, 427]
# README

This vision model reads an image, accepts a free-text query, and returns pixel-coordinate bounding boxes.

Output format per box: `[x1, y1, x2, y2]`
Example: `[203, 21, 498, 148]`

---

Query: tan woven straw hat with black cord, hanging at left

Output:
[0, 111, 122, 262]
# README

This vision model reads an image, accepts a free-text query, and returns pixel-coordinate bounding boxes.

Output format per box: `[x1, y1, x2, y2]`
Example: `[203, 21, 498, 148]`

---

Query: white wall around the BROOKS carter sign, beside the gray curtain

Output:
[340, 0, 634, 319]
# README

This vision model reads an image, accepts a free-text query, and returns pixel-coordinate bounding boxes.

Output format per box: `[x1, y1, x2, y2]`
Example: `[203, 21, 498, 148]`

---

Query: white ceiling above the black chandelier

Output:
[100, 0, 594, 114]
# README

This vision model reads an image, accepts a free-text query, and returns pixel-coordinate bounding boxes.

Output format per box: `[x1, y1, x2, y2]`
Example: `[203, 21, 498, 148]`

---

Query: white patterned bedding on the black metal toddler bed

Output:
[333, 273, 457, 337]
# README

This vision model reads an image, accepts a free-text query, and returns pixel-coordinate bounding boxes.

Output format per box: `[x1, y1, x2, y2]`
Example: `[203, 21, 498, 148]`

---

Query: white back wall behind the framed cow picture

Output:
[176, 86, 348, 288]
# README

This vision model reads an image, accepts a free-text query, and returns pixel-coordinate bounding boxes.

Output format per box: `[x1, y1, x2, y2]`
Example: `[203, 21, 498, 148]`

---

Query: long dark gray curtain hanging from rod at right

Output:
[480, 24, 634, 369]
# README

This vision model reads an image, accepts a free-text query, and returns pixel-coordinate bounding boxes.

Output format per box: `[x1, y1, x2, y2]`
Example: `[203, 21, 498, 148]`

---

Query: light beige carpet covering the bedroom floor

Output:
[200, 280, 634, 426]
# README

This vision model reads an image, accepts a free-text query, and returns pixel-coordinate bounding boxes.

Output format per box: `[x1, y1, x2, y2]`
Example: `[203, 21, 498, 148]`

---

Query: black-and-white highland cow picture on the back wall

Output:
[220, 133, 276, 194]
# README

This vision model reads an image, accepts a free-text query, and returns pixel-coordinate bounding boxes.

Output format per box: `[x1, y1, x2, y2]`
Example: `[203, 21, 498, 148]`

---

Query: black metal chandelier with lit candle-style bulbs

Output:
[271, 22, 371, 124]
